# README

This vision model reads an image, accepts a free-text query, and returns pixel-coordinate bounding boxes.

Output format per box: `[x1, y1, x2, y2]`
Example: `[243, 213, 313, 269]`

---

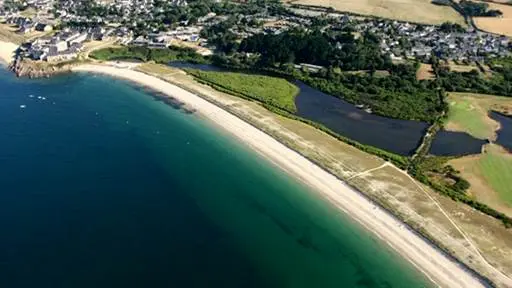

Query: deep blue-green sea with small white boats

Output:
[0, 70, 431, 288]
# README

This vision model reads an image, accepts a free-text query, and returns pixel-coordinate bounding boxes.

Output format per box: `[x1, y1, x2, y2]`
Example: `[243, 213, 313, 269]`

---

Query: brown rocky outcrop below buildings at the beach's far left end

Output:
[9, 58, 73, 78]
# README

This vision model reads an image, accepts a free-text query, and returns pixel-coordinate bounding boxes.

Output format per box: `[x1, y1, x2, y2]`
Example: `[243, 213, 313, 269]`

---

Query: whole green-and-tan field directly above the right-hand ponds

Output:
[445, 93, 512, 139]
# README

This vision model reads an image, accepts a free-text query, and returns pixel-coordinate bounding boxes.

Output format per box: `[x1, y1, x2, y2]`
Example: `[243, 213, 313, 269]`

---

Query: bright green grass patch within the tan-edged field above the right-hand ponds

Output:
[447, 99, 492, 139]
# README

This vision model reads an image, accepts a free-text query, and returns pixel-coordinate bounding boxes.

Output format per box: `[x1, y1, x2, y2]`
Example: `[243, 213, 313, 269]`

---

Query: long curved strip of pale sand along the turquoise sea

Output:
[73, 65, 492, 287]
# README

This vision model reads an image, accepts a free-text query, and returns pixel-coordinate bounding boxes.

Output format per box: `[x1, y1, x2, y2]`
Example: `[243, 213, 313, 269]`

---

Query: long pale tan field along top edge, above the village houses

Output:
[285, 0, 465, 25]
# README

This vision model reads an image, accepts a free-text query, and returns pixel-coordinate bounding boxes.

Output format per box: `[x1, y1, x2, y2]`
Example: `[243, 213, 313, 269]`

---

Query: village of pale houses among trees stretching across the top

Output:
[0, 0, 511, 63]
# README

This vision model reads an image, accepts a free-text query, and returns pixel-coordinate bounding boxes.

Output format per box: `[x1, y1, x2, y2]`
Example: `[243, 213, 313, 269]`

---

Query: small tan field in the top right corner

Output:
[474, 3, 512, 37]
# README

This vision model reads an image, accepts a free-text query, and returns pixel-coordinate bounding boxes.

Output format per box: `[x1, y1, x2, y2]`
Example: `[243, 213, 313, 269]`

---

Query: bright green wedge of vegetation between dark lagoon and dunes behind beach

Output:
[186, 69, 299, 113]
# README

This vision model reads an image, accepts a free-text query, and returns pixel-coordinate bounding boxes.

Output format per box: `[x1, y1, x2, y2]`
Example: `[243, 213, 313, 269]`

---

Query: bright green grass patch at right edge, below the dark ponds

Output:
[478, 150, 512, 205]
